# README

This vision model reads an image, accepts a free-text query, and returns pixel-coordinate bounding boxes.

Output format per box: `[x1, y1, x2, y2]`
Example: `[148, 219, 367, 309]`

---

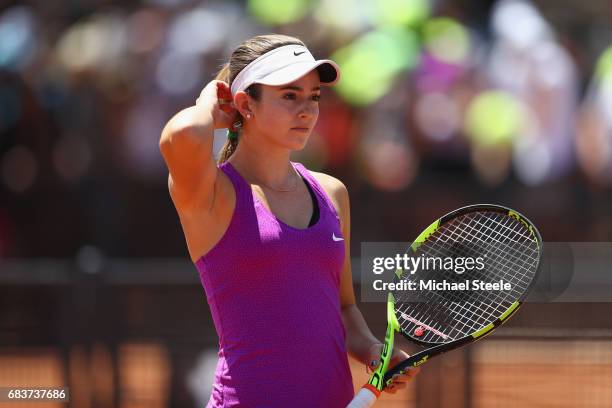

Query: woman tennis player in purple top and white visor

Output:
[160, 35, 417, 408]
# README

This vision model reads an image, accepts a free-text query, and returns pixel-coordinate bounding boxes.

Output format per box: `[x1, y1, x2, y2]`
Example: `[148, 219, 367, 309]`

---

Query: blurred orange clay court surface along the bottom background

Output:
[0, 340, 612, 408]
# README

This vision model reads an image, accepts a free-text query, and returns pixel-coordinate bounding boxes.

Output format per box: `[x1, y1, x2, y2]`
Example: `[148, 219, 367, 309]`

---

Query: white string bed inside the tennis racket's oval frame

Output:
[395, 212, 539, 343]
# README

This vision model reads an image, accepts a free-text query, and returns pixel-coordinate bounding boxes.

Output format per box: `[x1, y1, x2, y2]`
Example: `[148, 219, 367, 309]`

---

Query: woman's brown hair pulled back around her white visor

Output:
[215, 34, 305, 164]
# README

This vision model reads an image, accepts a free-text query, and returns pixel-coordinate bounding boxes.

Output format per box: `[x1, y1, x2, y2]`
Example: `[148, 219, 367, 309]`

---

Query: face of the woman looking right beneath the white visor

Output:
[249, 70, 321, 150]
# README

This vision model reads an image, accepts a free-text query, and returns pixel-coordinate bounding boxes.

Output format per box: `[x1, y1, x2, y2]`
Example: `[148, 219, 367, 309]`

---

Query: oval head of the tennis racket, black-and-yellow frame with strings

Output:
[392, 204, 543, 348]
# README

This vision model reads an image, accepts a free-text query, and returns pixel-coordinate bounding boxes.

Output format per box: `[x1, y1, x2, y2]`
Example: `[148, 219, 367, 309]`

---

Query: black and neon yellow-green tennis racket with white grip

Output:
[348, 204, 542, 408]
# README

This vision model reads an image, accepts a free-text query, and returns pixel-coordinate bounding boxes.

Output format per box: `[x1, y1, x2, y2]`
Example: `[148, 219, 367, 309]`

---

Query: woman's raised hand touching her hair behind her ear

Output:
[196, 80, 239, 129]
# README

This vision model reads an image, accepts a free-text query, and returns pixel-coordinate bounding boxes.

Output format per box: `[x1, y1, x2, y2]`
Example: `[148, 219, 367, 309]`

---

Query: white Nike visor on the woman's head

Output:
[232, 45, 340, 95]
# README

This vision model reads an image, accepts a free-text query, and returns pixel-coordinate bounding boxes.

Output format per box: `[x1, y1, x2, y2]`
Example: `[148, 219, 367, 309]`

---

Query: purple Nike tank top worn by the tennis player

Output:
[191, 162, 353, 408]
